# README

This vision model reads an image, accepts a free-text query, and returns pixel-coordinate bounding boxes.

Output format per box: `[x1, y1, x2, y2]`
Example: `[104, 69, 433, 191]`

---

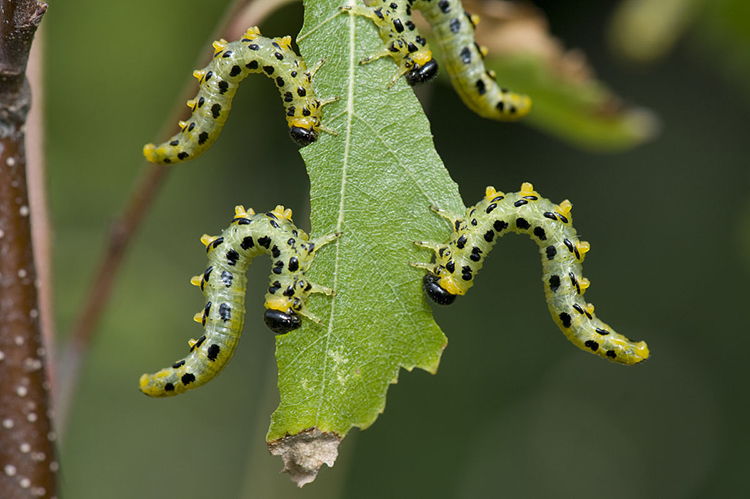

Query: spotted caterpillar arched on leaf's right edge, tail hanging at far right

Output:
[412, 183, 649, 365]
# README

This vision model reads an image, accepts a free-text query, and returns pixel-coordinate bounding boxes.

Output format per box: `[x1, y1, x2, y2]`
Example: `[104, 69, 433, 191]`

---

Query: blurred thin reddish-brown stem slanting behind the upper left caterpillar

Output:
[57, 0, 292, 431]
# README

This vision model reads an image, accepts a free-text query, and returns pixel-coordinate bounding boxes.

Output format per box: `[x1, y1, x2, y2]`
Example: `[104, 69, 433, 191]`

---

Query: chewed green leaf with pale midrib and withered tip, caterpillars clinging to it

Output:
[267, 1, 465, 485]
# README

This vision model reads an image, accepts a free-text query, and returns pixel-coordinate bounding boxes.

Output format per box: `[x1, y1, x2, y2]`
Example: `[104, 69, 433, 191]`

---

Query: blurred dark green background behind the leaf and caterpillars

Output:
[43, 0, 750, 499]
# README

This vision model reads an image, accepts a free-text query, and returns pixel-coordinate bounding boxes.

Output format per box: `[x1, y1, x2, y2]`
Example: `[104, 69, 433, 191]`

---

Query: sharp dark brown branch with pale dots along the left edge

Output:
[0, 0, 57, 499]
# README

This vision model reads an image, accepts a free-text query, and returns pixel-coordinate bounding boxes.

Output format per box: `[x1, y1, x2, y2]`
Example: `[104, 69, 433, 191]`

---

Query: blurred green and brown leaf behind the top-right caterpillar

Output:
[424, 0, 661, 153]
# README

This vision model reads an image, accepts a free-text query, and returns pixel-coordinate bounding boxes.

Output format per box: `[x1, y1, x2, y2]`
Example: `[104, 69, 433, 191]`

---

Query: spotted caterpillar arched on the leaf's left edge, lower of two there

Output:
[140, 206, 341, 397]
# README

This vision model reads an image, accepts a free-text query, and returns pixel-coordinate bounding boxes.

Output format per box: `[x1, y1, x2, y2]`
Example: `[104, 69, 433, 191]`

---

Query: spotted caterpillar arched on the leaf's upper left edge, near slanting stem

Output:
[143, 27, 335, 164]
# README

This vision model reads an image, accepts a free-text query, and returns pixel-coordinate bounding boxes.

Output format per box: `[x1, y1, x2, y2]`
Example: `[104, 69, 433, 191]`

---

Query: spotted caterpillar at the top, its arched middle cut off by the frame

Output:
[342, 0, 531, 121]
